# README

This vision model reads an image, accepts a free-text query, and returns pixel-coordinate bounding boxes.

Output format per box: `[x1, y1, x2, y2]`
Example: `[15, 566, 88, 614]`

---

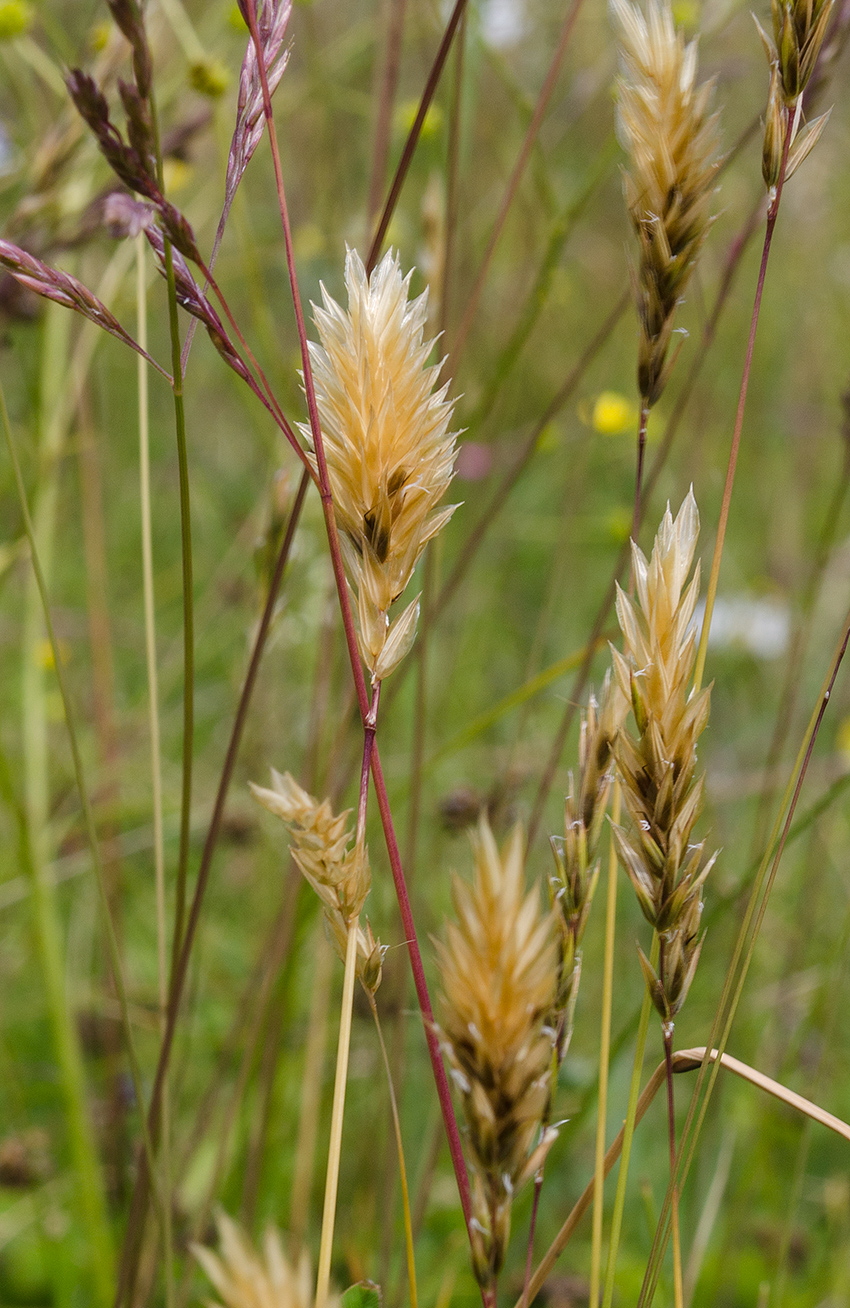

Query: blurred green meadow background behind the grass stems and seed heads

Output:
[0, 0, 850, 1308]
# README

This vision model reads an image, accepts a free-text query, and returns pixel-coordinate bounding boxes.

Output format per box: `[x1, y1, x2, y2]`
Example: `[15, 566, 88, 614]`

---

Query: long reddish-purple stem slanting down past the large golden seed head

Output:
[246, 0, 471, 1231]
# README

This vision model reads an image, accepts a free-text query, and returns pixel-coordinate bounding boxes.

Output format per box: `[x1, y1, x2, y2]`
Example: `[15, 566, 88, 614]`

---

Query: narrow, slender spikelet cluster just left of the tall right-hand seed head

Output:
[549, 674, 628, 1065]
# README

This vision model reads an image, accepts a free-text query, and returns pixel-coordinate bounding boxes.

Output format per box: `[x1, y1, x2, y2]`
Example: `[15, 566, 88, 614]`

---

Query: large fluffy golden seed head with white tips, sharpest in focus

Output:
[303, 250, 456, 681]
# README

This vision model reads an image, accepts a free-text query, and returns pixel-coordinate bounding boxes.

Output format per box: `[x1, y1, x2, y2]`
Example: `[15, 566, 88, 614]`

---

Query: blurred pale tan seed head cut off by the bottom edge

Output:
[192, 1213, 340, 1308]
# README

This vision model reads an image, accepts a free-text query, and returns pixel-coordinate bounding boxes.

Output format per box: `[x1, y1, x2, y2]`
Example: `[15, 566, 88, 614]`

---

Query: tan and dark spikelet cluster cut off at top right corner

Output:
[756, 0, 834, 190]
